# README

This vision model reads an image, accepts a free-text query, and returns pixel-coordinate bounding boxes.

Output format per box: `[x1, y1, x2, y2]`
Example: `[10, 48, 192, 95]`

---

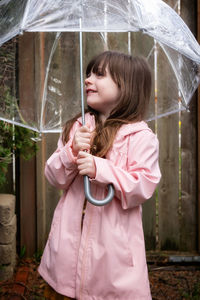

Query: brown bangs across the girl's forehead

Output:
[86, 52, 110, 77]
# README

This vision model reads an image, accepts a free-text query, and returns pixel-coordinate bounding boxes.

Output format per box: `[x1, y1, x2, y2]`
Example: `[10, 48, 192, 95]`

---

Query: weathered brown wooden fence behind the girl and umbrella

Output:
[0, 0, 200, 255]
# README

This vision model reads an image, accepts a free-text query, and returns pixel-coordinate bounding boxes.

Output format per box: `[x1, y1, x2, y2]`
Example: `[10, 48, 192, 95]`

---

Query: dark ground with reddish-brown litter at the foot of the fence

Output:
[0, 257, 200, 300]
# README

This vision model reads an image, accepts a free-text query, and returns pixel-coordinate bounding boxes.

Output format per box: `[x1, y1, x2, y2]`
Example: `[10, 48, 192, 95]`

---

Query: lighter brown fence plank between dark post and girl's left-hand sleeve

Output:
[35, 33, 59, 250]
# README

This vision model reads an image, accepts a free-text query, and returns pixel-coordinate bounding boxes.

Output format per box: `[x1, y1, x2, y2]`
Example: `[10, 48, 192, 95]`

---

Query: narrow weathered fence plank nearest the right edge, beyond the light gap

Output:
[180, 0, 198, 251]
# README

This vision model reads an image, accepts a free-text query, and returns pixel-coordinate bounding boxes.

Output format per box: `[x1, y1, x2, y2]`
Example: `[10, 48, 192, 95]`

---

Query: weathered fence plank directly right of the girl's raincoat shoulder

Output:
[157, 39, 180, 250]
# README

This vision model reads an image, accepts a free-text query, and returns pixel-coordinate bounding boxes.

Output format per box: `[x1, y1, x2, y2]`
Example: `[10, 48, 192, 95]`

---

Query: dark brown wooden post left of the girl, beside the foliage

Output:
[19, 33, 36, 256]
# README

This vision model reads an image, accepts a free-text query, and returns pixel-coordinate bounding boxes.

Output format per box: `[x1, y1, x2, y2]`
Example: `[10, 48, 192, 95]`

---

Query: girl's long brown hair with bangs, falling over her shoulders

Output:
[62, 51, 152, 157]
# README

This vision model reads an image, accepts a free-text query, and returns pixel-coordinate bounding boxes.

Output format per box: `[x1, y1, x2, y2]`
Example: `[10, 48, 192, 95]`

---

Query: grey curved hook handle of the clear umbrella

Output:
[84, 175, 115, 206]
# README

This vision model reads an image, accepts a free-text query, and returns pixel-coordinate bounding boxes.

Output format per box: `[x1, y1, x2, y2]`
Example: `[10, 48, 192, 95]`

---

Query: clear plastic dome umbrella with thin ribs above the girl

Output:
[0, 0, 200, 205]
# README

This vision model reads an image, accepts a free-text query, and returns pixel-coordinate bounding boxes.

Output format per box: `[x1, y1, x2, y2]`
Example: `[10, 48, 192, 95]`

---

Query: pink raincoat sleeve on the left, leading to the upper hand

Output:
[45, 122, 79, 190]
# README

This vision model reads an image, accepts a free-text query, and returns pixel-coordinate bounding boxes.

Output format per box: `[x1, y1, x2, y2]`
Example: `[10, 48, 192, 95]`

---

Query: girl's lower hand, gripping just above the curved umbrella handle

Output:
[76, 151, 96, 178]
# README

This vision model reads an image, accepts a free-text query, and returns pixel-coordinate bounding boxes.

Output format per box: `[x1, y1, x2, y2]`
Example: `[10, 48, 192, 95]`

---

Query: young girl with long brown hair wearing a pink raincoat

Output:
[39, 51, 160, 300]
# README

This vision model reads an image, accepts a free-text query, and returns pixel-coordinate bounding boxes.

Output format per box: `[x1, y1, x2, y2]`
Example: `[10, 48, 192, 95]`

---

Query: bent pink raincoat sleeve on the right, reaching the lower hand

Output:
[94, 131, 161, 209]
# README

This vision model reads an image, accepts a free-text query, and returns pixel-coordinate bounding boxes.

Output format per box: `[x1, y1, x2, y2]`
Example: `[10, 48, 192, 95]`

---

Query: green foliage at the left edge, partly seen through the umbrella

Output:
[0, 39, 37, 187]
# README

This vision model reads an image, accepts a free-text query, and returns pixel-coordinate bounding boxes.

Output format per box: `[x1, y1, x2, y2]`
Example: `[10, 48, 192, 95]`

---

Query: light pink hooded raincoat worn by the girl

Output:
[39, 114, 160, 300]
